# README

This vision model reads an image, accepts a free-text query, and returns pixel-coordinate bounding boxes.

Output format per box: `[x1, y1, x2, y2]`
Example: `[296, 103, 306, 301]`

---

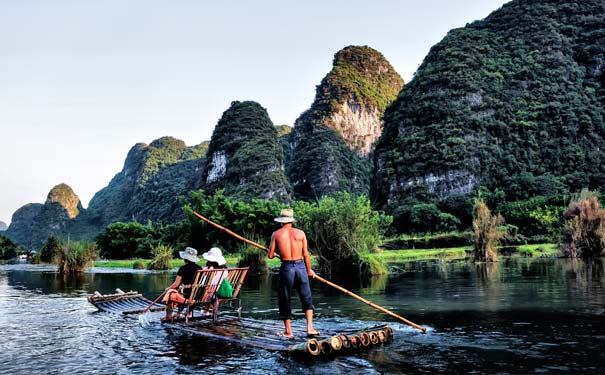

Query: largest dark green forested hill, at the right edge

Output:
[372, 0, 605, 210]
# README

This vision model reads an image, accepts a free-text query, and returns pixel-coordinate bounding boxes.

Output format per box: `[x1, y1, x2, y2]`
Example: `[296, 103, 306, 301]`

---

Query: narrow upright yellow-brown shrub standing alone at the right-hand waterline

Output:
[473, 198, 505, 262]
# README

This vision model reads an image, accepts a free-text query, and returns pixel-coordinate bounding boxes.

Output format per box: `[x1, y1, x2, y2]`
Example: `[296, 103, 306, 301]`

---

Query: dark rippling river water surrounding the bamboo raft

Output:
[0, 257, 605, 374]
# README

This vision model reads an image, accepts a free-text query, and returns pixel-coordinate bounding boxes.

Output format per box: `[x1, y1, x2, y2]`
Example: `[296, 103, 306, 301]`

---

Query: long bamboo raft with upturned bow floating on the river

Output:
[88, 290, 393, 358]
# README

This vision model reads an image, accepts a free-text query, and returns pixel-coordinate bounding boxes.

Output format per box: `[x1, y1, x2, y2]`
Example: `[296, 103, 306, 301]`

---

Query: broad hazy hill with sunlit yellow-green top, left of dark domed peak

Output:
[82, 137, 208, 227]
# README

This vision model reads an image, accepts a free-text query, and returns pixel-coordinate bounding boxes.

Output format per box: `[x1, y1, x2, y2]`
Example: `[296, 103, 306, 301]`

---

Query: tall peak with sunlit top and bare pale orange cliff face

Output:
[287, 46, 403, 199]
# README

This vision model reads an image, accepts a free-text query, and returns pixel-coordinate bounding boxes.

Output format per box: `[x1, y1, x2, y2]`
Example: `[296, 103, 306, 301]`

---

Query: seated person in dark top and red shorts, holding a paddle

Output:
[163, 247, 202, 320]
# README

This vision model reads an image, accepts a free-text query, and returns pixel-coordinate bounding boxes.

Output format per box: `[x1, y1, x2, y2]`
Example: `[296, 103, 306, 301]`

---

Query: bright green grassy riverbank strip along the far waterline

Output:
[89, 244, 559, 269]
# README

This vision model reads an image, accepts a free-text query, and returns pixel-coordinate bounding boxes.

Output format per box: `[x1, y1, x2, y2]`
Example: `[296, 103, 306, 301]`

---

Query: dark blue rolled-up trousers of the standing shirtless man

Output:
[277, 260, 315, 319]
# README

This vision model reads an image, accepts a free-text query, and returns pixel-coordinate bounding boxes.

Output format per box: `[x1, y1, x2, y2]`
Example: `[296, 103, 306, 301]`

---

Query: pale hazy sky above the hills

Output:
[0, 0, 507, 224]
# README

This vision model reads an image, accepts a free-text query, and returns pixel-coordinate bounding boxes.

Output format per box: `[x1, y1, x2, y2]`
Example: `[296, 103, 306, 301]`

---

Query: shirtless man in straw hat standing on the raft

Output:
[269, 209, 319, 338]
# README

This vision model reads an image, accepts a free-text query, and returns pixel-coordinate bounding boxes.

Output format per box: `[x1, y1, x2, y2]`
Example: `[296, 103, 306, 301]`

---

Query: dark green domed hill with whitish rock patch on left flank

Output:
[200, 101, 291, 201]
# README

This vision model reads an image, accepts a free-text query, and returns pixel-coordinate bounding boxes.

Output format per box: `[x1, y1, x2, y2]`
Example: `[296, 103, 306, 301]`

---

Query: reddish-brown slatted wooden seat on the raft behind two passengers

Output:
[177, 267, 250, 323]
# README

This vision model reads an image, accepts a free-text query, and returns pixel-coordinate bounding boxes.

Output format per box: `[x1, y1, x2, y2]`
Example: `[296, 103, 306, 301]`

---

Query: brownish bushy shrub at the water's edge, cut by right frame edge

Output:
[560, 192, 605, 258]
